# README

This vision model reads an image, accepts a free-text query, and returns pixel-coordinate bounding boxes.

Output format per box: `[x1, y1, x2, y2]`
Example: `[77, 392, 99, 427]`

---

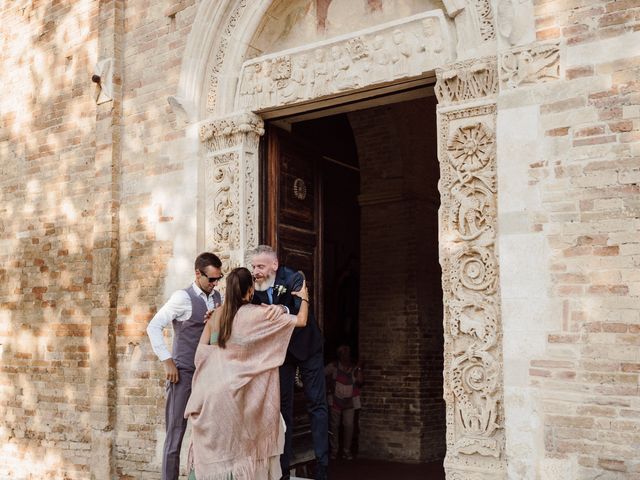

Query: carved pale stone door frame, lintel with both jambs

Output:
[200, 0, 504, 480]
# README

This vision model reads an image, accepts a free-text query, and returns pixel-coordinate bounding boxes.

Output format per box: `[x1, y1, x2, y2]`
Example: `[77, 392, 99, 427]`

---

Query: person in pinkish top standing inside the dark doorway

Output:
[324, 345, 364, 460]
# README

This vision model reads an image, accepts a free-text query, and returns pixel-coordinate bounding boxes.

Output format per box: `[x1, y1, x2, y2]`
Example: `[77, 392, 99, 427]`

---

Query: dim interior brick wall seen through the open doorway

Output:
[349, 99, 445, 461]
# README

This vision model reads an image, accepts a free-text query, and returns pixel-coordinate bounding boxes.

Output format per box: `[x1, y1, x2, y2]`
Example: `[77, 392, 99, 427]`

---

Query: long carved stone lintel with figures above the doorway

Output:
[236, 10, 454, 110]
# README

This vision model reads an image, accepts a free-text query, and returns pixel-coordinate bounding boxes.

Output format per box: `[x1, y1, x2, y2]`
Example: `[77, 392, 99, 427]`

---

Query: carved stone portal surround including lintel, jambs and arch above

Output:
[178, 0, 505, 479]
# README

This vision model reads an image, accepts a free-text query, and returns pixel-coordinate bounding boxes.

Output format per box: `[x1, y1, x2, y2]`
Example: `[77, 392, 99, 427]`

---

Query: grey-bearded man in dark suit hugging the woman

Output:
[251, 245, 329, 480]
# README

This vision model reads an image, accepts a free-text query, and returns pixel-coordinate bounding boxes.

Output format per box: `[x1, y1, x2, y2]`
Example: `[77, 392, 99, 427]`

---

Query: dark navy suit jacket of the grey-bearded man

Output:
[252, 267, 322, 361]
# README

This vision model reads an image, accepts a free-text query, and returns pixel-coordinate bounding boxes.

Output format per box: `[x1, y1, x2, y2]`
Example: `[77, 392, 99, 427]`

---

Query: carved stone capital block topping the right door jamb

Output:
[435, 57, 498, 105]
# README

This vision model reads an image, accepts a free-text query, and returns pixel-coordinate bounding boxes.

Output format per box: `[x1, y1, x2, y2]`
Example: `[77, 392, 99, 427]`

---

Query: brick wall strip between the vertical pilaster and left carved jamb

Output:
[115, 0, 200, 479]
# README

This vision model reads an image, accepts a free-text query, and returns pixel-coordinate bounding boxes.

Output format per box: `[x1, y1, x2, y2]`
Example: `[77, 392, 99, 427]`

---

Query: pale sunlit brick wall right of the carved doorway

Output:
[529, 0, 640, 478]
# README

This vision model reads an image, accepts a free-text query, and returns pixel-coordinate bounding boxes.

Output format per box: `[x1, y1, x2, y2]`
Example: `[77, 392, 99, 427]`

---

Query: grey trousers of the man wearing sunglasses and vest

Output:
[162, 369, 193, 480]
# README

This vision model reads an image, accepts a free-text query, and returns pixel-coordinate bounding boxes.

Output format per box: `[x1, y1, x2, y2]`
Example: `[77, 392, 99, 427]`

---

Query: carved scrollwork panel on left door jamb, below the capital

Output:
[206, 152, 241, 252]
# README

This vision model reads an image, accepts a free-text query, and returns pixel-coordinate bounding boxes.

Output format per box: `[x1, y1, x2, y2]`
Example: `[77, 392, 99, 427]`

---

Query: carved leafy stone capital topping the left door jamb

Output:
[200, 112, 264, 151]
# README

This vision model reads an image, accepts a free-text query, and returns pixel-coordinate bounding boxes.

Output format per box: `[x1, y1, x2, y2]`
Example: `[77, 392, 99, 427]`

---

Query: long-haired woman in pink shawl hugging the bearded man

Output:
[185, 268, 309, 480]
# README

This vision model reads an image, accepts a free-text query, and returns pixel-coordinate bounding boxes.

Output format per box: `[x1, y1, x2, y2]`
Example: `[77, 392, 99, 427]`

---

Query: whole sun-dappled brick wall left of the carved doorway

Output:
[0, 0, 198, 478]
